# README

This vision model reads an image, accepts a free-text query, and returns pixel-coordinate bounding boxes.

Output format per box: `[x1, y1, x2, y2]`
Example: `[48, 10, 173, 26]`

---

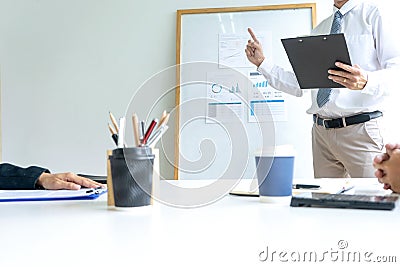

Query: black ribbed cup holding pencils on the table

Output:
[109, 146, 154, 207]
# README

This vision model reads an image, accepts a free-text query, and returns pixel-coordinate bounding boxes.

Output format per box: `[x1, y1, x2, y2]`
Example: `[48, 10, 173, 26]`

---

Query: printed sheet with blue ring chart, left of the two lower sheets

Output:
[206, 72, 244, 123]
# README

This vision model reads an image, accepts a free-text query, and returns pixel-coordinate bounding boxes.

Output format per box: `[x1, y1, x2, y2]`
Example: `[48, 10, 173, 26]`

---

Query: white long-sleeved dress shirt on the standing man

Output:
[258, 0, 400, 118]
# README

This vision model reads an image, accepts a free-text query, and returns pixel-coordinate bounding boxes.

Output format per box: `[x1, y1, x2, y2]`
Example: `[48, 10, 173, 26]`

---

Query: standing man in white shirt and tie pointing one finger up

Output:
[245, 0, 400, 178]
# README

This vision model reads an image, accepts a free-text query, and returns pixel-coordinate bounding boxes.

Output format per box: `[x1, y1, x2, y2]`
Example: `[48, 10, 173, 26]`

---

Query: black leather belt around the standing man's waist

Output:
[313, 111, 383, 129]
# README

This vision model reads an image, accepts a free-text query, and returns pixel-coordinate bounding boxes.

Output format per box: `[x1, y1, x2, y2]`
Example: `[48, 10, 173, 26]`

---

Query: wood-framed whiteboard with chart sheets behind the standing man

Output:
[174, 4, 315, 179]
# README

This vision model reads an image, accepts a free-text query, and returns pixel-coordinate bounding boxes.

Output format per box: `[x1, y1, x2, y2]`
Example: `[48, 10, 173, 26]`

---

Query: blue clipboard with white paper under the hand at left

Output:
[0, 188, 107, 202]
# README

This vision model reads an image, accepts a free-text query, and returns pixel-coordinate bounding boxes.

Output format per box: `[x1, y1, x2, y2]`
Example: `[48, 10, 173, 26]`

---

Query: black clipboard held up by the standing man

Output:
[281, 33, 352, 89]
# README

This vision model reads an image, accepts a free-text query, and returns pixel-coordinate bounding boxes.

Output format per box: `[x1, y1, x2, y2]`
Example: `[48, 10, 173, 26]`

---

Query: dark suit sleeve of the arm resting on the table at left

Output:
[0, 163, 50, 189]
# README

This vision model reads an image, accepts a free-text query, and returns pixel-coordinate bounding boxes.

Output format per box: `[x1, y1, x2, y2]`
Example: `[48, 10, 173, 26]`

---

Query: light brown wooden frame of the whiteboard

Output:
[174, 3, 316, 180]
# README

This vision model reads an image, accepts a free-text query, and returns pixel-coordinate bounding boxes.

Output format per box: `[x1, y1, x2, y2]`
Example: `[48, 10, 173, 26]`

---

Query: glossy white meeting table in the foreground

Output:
[0, 181, 400, 267]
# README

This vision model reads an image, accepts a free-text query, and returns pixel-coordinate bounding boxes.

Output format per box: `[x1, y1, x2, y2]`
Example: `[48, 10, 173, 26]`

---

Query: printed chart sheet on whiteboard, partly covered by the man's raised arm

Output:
[248, 71, 287, 122]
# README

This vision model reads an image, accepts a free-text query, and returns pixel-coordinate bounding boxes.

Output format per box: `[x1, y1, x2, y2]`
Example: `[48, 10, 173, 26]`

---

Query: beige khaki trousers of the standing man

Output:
[312, 118, 384, 178]
